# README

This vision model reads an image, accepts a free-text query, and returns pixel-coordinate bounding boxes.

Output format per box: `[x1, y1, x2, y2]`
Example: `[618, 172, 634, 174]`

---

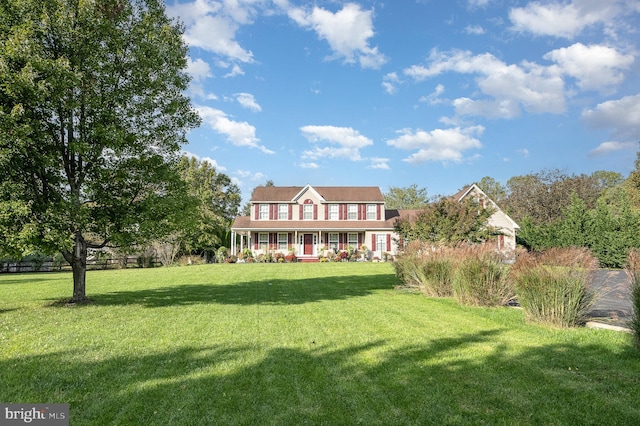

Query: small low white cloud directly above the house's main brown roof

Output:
[300, 126, 373, 161]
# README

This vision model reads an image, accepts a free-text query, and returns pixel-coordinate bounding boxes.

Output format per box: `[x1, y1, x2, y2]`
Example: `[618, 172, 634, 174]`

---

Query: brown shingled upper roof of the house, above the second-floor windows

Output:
[251, 185, 384, 203]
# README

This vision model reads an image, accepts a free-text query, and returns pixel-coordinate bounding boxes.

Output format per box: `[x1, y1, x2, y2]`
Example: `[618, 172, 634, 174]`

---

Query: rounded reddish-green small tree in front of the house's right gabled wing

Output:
[395, 197, 499, 244]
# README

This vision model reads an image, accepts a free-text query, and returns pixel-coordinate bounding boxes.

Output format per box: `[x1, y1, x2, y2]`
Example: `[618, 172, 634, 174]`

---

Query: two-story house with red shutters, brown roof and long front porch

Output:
[231, 185, 518, 260]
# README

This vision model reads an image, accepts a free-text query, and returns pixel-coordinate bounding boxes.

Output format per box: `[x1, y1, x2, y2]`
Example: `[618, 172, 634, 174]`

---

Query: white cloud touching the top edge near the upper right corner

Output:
[509, 0, 624, 39]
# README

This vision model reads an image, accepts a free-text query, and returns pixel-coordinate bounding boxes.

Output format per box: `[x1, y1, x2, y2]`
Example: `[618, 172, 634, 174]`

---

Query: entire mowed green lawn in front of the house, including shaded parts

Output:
[0, 263, 640, 425]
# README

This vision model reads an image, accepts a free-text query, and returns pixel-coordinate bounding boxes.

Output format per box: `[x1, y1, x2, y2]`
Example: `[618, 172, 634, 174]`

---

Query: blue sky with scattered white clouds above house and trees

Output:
[167, 0, 640, 201]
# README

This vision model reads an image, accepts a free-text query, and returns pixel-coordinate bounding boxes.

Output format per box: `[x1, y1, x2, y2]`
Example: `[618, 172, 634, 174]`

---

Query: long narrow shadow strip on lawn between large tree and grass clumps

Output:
[91, 275, 397, 308]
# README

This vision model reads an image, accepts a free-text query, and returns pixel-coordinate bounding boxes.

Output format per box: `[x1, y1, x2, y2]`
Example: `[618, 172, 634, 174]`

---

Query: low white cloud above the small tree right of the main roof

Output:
[387, 126, 484, 164]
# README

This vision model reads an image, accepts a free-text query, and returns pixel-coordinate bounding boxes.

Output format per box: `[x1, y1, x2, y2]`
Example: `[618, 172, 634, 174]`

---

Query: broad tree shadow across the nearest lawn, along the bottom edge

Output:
[0, 330, 640, 425]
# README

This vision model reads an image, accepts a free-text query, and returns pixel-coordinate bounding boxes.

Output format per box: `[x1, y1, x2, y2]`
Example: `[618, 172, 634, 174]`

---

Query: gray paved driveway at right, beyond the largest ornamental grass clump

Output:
[589, 269, 633, 327]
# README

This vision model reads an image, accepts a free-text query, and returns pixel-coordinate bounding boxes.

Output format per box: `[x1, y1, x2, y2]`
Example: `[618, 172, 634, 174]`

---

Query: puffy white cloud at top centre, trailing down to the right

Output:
[288, 3, 387, 68]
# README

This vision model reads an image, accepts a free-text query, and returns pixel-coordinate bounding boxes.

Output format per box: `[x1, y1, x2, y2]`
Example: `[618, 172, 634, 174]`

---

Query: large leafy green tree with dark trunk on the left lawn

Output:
[0, 0, 199, 302]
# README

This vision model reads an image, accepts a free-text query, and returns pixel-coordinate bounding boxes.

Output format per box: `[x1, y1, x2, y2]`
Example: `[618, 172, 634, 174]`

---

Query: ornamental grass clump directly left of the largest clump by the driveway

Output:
[452, 245, 515, 306]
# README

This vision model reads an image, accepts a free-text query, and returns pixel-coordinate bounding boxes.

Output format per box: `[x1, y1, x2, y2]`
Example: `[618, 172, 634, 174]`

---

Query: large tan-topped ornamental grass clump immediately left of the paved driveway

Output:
[511, 247, 598, 327]
